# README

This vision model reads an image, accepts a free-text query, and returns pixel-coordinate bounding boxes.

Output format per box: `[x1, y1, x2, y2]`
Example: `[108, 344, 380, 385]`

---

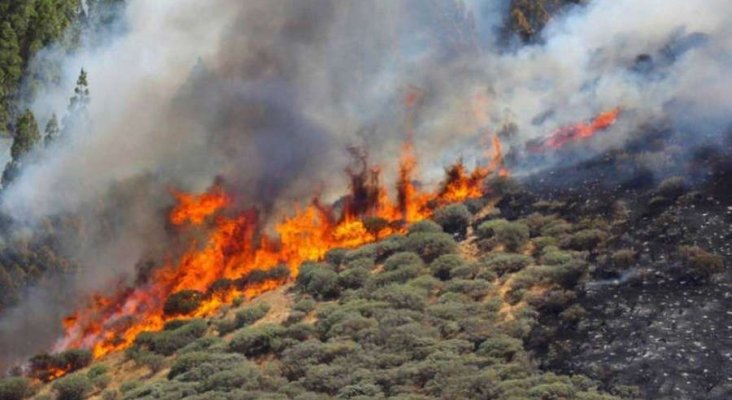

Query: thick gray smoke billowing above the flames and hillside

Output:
[0, 0, 732, 368]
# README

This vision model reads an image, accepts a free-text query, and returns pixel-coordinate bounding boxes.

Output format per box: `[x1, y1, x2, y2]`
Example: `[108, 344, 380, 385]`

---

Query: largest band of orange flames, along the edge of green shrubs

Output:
[50, 131, 505, 378]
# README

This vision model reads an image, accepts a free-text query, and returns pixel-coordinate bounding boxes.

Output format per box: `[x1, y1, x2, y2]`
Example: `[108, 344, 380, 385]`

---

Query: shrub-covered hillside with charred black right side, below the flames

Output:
[0, 163, 731, 399]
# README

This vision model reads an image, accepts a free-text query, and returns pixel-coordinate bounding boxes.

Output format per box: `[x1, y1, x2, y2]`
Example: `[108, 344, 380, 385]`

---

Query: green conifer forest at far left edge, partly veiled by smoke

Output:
[0, 0, 123, 311]
